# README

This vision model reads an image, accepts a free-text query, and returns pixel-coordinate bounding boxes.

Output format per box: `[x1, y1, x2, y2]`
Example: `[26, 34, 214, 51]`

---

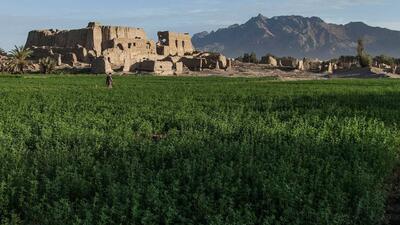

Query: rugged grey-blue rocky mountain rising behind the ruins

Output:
[193, 14, 400, 59]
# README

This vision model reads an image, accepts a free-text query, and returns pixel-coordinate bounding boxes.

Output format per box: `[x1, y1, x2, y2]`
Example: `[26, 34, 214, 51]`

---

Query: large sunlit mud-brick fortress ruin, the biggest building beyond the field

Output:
[25, 22, 231, 75]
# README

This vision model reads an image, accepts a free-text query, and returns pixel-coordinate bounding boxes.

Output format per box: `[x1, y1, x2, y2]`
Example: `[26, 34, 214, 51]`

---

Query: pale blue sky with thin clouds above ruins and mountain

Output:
[0, 0, 400, 50]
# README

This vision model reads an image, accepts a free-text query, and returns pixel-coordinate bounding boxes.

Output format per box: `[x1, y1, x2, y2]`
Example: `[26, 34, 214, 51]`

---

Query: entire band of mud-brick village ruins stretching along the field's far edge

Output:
[0, 22, 400, 78]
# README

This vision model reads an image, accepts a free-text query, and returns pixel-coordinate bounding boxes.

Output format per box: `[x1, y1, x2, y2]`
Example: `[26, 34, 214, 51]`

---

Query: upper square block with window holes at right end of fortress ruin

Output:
[157, 31, 194, 56]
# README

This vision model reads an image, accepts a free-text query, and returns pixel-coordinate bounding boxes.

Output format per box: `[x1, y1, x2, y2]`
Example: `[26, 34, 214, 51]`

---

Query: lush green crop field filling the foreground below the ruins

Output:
[0, 76, 400, 225]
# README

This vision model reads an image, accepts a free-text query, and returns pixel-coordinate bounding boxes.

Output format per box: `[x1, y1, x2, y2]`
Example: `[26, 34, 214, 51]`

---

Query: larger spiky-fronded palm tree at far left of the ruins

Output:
[9, 46, 33, 73]
